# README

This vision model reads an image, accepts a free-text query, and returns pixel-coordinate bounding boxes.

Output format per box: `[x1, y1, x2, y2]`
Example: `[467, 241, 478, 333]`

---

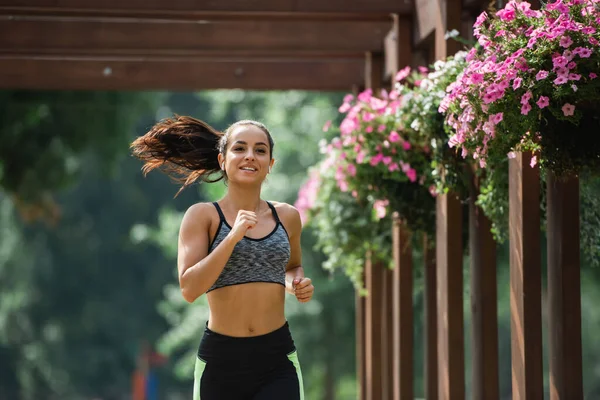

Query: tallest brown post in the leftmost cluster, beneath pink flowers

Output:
[392, 215, 414, 400]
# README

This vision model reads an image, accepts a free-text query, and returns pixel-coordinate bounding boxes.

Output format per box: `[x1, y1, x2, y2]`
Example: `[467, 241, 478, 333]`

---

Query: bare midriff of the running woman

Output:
[208, 282, 285, 337]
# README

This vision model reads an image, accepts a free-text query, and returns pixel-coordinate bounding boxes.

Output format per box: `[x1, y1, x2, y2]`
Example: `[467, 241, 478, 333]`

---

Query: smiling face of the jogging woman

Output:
[219, 125, 275, 183]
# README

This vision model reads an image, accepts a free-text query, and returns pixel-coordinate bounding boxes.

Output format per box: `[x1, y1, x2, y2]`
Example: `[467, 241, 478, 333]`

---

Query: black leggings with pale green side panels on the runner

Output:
[194, 323, 304, 400]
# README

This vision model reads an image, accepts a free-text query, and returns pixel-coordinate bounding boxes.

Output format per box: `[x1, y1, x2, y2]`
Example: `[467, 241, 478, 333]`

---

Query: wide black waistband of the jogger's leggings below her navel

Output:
[198, 322, 296, 362]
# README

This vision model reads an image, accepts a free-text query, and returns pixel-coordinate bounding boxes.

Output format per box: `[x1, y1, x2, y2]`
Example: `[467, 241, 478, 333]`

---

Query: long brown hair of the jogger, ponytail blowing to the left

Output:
[130, 115, 275, 196]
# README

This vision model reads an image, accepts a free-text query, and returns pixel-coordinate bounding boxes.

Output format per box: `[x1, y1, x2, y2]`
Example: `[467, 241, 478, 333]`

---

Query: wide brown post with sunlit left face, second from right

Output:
[508, 153, 544, 400]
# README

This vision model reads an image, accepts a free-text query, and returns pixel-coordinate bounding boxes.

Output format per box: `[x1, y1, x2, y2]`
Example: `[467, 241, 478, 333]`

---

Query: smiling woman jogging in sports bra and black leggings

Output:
[131, 116, 314, 400]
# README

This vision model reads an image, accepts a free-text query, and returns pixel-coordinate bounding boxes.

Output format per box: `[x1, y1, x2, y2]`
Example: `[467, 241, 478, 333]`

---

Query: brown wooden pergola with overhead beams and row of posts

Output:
[0, 0, 583, 400]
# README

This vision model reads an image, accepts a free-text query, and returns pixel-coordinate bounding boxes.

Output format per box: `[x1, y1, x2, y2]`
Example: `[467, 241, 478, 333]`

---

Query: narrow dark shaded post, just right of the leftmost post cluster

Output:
[423, 235, 438, 400]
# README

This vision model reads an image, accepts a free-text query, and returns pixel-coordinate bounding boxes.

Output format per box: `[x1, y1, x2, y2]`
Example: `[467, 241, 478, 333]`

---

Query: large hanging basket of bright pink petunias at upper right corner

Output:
[441, 0, 600, 176]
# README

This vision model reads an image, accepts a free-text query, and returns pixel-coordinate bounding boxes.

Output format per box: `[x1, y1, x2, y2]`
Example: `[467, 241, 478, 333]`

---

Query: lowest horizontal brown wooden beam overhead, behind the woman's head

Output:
[0, 56, 364, 91]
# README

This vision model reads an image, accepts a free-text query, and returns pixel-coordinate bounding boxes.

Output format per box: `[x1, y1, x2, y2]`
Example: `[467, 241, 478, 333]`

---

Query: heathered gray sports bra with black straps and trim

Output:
[207, 201, 291, 293]
